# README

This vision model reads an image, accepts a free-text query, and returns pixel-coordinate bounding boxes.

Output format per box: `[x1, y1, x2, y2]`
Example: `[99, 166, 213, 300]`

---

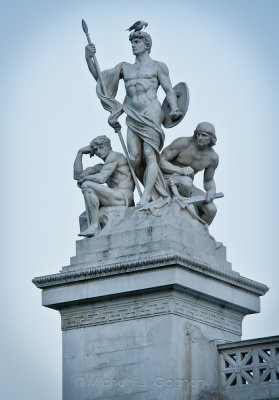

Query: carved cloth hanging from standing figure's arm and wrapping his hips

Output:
[96, 62, 169, 200]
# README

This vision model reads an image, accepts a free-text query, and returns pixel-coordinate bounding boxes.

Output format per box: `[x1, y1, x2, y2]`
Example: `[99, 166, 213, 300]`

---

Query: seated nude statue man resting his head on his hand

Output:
[74, 135, 134, 237]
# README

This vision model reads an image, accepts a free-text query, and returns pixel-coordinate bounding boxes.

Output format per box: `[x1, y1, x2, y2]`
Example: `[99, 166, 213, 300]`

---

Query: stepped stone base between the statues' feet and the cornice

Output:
[71, 200, 231, 272]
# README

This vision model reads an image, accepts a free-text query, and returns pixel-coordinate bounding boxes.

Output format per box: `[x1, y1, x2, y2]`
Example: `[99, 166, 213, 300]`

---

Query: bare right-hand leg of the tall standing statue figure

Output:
[139, 142, 159, 204]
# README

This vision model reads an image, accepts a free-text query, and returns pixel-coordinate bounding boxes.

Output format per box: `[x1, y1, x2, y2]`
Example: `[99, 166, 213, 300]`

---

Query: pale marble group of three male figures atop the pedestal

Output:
[74, 21, 220, 237]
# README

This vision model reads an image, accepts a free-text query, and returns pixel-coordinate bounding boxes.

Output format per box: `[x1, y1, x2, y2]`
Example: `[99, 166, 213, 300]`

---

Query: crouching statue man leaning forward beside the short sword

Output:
[161, 122, 219, 225]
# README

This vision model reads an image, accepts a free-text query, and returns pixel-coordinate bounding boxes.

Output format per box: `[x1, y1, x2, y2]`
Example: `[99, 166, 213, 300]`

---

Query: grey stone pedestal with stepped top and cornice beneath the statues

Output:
[34, 204, 267, 400]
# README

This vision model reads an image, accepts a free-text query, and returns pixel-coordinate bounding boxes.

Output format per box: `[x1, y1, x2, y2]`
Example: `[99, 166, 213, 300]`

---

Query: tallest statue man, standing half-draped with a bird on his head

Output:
[85, 31, 181, 204]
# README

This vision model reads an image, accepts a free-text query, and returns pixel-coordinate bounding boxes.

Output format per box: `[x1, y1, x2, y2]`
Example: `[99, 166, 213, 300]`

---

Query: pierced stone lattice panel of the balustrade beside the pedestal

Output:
[221, 338, 279, 389]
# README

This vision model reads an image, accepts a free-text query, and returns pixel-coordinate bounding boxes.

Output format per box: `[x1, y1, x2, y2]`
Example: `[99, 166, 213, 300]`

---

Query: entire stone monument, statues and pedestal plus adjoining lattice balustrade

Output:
[33, 21, 274, 400]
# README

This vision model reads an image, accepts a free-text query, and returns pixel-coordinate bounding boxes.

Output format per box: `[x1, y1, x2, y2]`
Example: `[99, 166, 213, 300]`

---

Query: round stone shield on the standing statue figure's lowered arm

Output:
[162, 82, 189, 128]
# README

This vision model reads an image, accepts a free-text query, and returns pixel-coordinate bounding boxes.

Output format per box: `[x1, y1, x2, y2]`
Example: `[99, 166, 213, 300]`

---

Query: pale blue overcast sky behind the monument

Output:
[0, 0, 279, 400]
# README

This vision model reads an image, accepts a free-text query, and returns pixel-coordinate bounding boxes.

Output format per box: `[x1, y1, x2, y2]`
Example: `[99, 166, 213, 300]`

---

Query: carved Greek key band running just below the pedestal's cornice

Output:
[60, 296, 243, 335]
